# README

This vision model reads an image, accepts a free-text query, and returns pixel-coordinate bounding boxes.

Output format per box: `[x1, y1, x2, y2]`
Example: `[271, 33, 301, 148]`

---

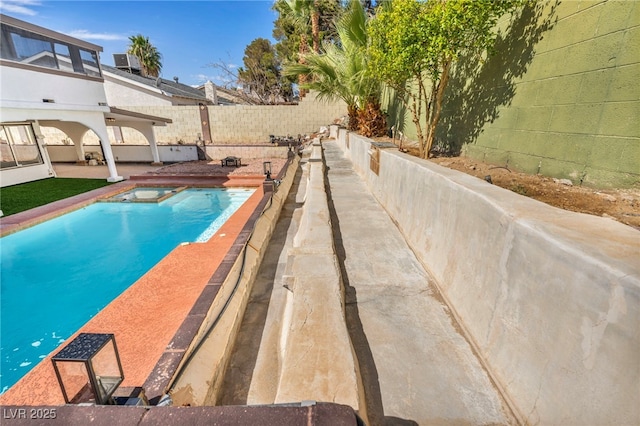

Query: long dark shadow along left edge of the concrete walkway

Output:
[324, 161, 417, 426]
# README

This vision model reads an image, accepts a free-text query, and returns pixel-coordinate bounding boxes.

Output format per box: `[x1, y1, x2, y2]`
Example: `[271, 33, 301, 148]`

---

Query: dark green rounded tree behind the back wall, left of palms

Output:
[238, 38, 287, 104]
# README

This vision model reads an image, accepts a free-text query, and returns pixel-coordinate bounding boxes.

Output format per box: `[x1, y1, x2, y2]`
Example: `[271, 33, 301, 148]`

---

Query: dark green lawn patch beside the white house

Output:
[0, 178, 111, 216]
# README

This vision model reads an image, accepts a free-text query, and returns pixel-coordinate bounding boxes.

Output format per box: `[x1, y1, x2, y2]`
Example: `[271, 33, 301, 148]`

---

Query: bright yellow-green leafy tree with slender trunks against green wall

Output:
[369, 0, 525, 158]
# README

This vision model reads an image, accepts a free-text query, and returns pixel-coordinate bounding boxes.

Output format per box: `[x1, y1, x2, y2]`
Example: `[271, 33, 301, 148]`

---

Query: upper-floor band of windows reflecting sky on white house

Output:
[0, 24, 102, 77]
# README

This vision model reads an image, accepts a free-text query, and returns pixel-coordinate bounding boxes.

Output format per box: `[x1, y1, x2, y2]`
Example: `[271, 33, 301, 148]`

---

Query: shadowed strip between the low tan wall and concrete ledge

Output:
[216, 167, 302, 405]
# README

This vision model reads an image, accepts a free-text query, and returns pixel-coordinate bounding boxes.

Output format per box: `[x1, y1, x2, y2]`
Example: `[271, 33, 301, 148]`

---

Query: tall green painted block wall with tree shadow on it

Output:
[388, 0, 640, 188]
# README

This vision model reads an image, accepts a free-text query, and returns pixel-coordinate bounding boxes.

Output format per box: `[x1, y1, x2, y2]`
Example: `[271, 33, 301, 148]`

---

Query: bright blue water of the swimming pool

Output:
[0, 188, 254, 393]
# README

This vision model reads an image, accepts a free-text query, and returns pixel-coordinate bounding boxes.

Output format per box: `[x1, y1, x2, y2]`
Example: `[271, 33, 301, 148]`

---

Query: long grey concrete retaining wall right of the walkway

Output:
[338, 129, 640, 425]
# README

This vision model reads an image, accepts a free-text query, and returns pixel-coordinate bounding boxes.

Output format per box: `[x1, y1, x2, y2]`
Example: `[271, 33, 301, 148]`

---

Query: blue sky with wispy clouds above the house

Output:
[0, 0, 277, 85]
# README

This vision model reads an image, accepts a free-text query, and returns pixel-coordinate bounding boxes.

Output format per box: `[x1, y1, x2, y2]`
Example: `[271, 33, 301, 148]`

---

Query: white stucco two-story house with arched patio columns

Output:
[0, 14, 171, 187]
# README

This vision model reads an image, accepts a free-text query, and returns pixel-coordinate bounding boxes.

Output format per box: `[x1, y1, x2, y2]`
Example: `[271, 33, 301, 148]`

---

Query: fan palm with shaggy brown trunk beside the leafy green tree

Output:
[284, 0, 386, 137]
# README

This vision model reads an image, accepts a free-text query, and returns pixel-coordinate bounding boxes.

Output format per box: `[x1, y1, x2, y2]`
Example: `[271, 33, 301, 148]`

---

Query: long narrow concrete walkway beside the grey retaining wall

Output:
[323, 141, 514, 425]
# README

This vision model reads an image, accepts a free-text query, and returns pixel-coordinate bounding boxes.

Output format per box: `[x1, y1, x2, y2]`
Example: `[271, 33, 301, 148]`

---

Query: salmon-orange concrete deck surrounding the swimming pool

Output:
[0, 166, 277, 406]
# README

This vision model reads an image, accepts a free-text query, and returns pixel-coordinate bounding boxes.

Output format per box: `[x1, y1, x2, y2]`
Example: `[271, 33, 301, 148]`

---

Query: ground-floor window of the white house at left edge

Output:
[0, 124, 43, 169]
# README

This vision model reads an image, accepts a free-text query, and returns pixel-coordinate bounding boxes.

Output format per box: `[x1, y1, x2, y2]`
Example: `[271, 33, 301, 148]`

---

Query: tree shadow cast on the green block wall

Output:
[434, 0, 560, 156]
